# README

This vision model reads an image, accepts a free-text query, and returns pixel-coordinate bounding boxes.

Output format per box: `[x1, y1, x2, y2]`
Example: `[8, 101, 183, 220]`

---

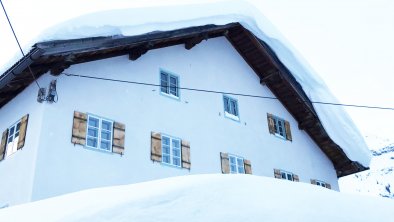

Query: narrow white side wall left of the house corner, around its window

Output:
[0, 80, 45, 207]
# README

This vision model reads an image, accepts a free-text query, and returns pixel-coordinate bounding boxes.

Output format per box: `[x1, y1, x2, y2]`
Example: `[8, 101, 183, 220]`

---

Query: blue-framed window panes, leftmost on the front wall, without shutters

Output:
[86, 115, 113, 152]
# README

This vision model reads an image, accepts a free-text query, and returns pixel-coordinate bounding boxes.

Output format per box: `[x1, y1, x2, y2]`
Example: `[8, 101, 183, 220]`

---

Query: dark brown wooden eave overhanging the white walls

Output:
[0, 23, 368, 177]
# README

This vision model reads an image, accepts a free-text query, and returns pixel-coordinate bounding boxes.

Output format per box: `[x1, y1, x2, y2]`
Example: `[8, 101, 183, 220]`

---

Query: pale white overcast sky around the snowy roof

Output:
[0, 0, 394, 149]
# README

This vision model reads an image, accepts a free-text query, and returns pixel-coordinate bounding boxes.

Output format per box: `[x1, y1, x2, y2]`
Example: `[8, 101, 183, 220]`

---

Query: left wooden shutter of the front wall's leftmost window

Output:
[71, 111, 88, 145]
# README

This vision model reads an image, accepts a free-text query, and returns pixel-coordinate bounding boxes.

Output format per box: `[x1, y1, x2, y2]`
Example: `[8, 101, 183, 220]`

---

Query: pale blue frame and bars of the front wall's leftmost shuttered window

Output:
[85, 113, 115, 153]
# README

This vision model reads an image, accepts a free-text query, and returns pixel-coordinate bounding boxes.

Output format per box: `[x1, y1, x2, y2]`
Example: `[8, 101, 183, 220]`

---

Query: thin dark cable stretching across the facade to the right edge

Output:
[62, 72, 394, 111]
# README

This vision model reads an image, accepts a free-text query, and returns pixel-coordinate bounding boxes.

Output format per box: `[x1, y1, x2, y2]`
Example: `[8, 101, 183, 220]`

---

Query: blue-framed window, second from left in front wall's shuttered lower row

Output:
[161, 135, 181, 167]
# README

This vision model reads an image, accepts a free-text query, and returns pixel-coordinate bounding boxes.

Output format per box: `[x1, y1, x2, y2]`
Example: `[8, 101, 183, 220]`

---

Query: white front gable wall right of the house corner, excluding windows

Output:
[19, 38, 338, 200]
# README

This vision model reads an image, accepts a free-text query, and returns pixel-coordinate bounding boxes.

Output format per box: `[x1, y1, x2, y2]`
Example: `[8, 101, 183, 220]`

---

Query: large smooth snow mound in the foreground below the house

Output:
[0, 174, 394, 222]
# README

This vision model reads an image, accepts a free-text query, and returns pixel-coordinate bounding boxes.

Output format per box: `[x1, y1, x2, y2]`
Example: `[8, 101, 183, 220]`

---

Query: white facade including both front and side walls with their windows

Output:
[0, 37, 339, 207]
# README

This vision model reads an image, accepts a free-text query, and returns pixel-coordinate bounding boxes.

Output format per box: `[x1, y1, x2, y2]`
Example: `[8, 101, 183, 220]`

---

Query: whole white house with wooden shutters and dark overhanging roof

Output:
[0, 4, 368, 206]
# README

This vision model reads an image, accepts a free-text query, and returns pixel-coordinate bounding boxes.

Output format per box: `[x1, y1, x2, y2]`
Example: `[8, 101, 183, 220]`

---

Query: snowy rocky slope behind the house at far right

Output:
[339, 143, 394, 199]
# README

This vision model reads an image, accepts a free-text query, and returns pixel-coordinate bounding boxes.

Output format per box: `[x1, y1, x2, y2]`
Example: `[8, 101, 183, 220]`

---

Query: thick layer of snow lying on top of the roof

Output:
[0, 1, 371, 166]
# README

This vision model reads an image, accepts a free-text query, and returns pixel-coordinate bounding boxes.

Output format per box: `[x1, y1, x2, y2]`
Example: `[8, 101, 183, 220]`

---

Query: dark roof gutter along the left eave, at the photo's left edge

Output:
[0, 48, 44, 89]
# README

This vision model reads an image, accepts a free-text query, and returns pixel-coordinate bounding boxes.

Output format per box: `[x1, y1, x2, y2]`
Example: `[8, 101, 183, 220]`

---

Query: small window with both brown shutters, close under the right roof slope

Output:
[267, 113, 292, 141]
